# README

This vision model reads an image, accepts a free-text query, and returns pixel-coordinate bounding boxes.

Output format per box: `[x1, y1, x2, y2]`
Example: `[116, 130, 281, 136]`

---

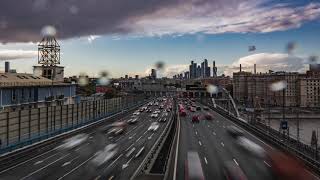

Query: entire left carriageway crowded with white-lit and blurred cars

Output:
[0, 100, 172, 180]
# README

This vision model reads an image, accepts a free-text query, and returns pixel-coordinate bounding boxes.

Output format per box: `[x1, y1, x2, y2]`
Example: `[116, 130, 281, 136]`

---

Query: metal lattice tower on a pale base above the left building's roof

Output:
[33, 36, 64, 82]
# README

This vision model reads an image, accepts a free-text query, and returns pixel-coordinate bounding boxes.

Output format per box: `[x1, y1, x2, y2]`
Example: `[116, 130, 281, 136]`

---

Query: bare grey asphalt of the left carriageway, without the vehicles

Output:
[0, 100, 172, 180]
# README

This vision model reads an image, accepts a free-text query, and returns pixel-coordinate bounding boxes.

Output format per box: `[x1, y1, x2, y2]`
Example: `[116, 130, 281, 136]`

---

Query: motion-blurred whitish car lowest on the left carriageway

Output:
[90, 144, 118, 167]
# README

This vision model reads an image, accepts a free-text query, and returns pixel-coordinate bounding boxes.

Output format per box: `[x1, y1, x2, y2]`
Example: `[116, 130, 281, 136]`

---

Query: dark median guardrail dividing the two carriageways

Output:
[130, 99, 176, 180]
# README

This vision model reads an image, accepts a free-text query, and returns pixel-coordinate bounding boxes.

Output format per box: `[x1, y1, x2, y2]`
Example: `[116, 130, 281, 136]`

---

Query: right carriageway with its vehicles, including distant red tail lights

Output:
[175, 100, 317, 180]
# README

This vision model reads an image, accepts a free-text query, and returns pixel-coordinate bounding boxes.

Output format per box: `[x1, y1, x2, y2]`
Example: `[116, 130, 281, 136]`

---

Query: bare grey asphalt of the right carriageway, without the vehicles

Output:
[176, 101, 282, 180]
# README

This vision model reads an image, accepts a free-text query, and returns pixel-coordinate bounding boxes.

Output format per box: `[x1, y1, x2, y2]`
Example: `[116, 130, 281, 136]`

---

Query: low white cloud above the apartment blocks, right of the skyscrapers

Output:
[224, 53, 307, 75]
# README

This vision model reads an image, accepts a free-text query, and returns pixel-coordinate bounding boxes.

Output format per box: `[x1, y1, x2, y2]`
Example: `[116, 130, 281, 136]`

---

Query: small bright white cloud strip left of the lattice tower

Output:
[0, 50, 38, 60]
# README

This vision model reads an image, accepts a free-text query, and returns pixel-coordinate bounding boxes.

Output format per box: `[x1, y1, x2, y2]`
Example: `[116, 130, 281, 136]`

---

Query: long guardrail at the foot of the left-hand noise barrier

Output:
[0, 101, 146, 171]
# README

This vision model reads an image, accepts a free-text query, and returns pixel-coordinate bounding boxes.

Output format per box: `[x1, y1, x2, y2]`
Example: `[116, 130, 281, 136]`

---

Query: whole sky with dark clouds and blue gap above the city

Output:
[0, 0, 320, 77]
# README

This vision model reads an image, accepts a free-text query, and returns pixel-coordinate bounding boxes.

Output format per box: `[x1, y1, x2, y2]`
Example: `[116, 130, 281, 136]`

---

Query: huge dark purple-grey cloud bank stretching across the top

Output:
[0, 0, 320, 43]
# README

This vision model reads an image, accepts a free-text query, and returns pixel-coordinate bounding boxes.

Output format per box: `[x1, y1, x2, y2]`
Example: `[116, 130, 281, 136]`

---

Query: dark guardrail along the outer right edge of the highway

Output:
[204, 102, 320, 175]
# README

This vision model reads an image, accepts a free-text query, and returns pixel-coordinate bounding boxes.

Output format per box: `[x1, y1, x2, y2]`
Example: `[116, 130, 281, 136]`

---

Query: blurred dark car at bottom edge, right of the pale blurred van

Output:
[223, 161, 248, 180]
